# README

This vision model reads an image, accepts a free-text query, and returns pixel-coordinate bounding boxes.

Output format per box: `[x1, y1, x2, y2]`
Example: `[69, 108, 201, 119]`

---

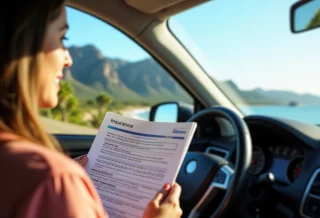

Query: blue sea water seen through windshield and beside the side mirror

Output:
[137, 105, 320, 124]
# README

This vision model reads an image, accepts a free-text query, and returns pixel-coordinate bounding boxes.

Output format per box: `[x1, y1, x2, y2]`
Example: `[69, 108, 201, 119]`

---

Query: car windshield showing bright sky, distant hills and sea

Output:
[169, 0, 320, 124]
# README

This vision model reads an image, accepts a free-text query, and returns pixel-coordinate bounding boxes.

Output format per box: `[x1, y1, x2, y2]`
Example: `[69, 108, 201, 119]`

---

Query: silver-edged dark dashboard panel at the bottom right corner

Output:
[300, 169, 320, 218]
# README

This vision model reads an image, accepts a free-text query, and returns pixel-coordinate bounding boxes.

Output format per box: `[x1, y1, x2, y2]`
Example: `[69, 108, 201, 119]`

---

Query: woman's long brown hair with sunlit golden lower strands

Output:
[0, 0, 64, 151]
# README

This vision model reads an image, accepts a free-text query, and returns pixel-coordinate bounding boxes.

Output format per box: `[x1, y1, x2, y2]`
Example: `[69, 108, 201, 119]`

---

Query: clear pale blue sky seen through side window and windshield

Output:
[67, 0, 320, 95]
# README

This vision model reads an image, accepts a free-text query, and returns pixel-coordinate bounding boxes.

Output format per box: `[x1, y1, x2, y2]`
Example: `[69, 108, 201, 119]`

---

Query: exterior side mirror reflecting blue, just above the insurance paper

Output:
[149, 102, 193, 122]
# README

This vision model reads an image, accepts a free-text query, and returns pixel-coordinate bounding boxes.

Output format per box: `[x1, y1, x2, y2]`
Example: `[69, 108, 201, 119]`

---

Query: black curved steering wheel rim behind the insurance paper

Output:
[180, 106, 252, 218]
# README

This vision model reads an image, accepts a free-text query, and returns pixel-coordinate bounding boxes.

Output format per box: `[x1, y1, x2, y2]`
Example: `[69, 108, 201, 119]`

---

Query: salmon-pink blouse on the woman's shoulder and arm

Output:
[0, 133, 107, 218]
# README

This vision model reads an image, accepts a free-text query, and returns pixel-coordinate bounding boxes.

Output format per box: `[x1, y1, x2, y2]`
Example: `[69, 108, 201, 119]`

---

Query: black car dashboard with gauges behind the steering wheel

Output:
[190, 116, 320, 217]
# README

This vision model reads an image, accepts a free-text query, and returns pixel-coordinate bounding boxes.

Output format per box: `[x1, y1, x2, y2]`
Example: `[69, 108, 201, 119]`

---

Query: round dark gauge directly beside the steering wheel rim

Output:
[249, 146, 266, 175]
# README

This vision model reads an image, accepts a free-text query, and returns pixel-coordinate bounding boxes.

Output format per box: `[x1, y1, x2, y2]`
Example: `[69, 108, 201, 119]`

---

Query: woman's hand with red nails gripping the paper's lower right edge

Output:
[143, 183, 182, 218]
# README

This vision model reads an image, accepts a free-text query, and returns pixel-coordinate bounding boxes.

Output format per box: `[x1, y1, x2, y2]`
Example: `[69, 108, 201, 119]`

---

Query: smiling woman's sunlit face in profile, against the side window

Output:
[38, 7, 72, 108]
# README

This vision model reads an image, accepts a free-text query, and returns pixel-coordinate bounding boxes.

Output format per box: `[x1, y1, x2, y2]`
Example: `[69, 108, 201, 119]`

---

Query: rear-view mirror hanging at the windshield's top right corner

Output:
[290, 0, 320, 33]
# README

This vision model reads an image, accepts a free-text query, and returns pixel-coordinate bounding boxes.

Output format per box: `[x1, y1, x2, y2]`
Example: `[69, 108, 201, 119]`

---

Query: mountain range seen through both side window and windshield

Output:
[64, 45, 320, 105]
